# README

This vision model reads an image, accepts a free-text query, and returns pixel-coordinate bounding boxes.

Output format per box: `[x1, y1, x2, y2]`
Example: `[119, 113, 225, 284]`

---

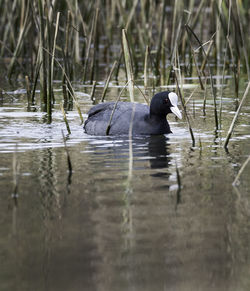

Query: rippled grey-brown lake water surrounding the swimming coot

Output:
[0, 82, 250, 291]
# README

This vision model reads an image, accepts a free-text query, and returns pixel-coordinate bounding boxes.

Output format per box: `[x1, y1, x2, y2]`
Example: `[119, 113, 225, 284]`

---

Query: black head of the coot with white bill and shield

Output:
[150, 91, 182, 118]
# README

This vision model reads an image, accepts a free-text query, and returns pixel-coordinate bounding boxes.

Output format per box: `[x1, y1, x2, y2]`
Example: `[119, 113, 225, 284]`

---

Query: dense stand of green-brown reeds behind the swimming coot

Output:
[0, 0, 250, 145]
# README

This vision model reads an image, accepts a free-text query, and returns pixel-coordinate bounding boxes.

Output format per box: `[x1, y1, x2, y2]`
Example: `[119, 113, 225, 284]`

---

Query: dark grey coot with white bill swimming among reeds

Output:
[84, 91, 182, 135]
